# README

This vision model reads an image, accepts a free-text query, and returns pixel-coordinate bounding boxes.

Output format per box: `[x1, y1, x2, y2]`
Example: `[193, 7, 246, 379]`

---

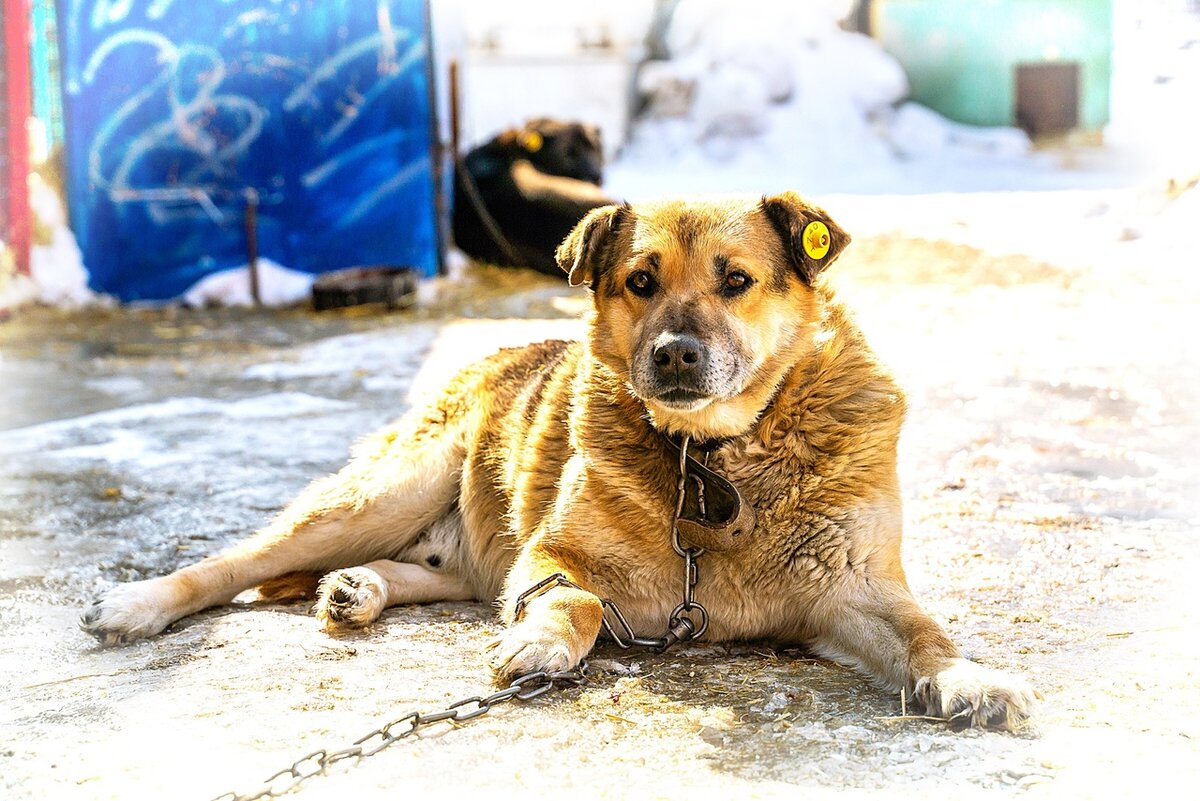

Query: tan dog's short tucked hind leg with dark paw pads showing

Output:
[316, 559, 475, 628]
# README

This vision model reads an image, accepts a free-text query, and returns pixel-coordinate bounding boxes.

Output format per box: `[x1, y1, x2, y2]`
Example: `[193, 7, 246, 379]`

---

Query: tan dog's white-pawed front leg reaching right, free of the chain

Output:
[809, 576, 1037, 730]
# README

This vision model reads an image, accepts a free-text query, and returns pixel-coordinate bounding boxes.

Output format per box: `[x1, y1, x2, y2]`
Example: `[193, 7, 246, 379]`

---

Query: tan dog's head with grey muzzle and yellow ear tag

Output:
[557, 192, 850, 439]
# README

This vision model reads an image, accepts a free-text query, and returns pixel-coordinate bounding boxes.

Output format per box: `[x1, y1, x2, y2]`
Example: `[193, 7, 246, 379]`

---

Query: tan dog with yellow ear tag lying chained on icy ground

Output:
[82, 193, 1036, 728]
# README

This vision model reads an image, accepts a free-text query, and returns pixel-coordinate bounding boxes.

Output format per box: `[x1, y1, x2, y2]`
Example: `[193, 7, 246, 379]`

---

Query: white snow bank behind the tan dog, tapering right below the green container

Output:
[607, 0, 1045, 200]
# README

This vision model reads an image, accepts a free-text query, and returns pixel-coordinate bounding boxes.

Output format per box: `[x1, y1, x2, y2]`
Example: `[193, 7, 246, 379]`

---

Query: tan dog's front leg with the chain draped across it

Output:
[488, 541, 604, 683]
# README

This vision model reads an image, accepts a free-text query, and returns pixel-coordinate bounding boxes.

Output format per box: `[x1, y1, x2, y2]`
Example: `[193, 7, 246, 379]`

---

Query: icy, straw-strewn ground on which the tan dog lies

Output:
[0, 190, 1200, 800]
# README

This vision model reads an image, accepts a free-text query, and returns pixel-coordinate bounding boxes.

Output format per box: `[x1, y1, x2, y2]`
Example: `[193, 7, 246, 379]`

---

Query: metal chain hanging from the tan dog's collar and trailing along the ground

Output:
[212, 436, 708, 801]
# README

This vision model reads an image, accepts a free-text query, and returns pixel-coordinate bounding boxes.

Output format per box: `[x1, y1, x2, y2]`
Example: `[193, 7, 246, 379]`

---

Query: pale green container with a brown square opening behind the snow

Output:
[870, 0, 1112, 134]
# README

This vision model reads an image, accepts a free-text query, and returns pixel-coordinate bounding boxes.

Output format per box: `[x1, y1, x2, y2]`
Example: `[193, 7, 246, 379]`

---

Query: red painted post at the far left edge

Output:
[0, 0, 32, 273]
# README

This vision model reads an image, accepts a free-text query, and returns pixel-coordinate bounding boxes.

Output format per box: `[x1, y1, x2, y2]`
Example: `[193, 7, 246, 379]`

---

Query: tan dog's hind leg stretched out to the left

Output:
[80, 416, 466, 644]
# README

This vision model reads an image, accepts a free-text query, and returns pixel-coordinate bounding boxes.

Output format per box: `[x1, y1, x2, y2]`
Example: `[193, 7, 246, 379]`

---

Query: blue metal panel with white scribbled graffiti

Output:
[59, 0, 438, 300]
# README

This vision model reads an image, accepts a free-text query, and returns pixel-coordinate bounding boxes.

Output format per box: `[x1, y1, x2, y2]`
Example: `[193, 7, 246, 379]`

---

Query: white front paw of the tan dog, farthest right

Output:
[914, 660, 1038, 731]
